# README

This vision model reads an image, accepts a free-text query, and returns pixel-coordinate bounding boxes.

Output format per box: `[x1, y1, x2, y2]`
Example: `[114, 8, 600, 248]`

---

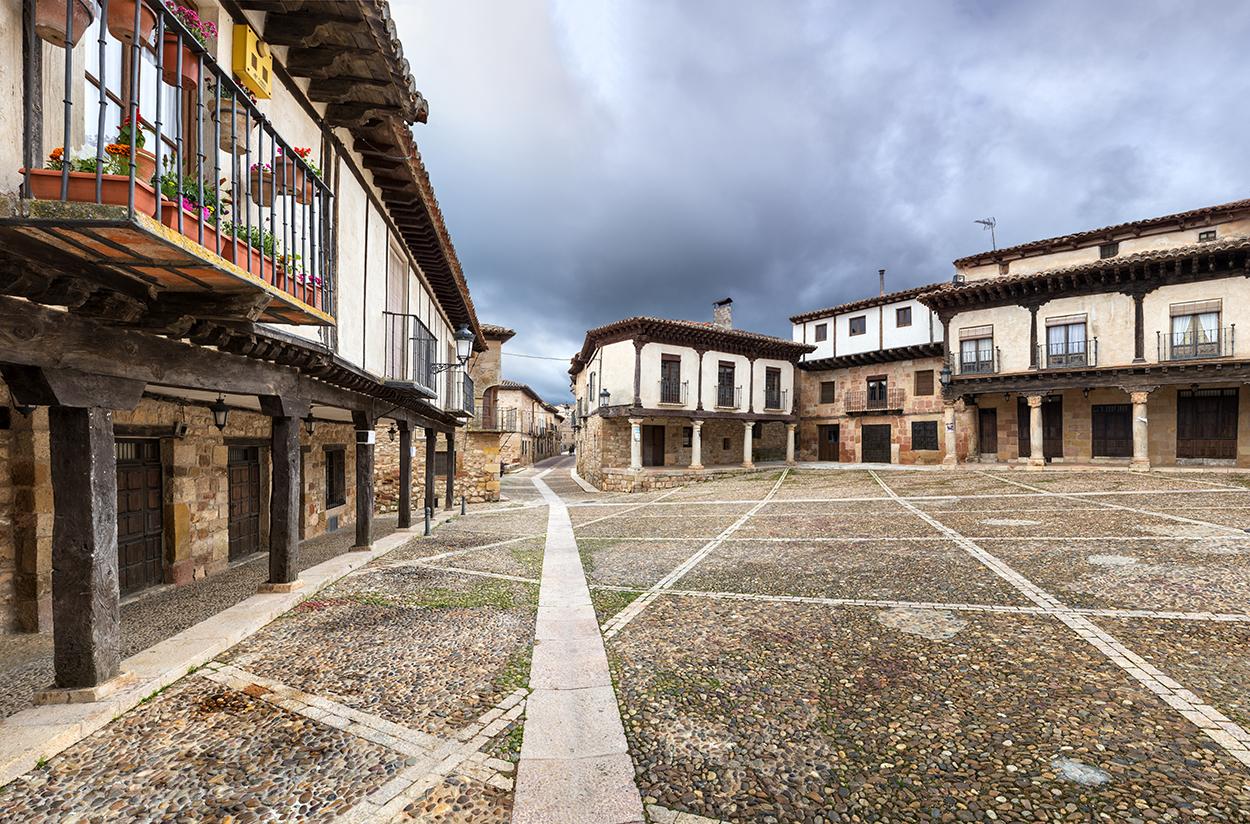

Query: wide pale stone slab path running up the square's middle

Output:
[513, 473, 644, 824]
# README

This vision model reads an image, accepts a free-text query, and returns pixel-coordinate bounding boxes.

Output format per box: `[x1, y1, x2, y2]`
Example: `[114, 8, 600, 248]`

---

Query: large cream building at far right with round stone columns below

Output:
[920, 200, 1250, 468]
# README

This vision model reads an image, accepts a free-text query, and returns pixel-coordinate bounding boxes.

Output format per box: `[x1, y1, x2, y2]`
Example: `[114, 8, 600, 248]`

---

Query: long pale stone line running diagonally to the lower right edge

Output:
[869, 470, 1250, 766]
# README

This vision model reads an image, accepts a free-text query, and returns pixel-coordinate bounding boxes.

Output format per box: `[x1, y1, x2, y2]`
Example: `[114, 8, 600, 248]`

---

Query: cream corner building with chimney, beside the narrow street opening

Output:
[569, 299, 815, 491]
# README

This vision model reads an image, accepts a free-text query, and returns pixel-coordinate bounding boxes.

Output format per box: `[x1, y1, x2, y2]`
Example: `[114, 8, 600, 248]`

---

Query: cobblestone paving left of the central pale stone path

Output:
[0, 474, 546, 824]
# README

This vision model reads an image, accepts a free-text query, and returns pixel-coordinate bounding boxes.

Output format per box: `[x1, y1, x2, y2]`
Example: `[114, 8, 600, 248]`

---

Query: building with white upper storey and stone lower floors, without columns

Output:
[790, 283, 955, 464]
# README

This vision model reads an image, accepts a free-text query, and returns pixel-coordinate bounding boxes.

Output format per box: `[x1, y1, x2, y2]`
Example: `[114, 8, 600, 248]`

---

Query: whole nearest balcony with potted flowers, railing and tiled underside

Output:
[0, 0, 335, 325]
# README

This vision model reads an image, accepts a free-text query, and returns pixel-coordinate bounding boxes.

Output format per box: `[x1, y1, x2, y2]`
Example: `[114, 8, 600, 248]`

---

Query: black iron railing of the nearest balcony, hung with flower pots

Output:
[21, 0, 335, 313]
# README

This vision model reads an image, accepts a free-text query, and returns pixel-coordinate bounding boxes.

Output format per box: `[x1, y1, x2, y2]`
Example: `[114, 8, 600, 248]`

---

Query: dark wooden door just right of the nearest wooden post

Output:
[115, 440, 165, 594]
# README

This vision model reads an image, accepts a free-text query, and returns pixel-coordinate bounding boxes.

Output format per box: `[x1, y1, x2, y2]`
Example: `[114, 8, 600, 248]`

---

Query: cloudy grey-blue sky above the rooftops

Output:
[391, 0, 1250, 401]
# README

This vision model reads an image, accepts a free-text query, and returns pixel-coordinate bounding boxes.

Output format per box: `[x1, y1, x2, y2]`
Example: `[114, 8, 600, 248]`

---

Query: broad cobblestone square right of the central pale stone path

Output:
[590, 469, 1250, 823]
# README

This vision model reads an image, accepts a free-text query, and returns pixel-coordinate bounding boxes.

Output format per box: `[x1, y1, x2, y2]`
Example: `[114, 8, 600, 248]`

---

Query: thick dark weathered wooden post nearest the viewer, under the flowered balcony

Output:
[48, 406, 121, 690]
